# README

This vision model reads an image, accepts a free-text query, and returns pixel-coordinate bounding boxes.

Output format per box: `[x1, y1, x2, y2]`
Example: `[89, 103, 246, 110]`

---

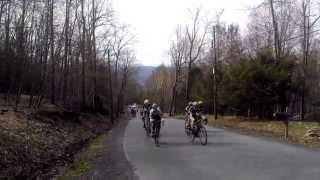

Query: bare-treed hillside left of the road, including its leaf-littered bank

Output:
[0, 0, 140, 179]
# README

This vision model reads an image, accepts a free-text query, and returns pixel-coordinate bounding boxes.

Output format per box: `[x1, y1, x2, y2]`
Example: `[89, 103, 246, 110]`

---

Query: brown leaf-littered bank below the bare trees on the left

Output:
[0, 104, 112, 179]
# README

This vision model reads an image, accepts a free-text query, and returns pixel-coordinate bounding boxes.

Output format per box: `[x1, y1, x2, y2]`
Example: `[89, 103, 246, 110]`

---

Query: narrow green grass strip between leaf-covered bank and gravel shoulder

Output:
[58, 134, 108, 180]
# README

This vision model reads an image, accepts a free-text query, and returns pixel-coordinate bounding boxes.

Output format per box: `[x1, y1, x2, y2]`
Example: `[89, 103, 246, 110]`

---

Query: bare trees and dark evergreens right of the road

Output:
[145, 0, 320, 120]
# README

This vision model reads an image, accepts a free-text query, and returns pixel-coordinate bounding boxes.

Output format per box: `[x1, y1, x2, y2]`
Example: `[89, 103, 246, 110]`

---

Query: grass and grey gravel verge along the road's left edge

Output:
[58, 117, 138, 180]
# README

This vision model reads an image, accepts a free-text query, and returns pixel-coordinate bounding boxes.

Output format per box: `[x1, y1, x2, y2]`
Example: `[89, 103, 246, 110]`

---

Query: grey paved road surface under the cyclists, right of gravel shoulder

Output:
[124, 119, 320, 180]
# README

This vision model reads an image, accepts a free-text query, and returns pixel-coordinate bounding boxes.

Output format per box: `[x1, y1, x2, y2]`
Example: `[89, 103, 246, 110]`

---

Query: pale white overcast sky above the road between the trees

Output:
[113, 0, 262, 66]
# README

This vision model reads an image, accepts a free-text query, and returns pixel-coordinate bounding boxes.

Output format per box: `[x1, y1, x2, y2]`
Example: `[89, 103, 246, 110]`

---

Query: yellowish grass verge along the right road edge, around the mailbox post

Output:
[175, 114, 320, 149]
